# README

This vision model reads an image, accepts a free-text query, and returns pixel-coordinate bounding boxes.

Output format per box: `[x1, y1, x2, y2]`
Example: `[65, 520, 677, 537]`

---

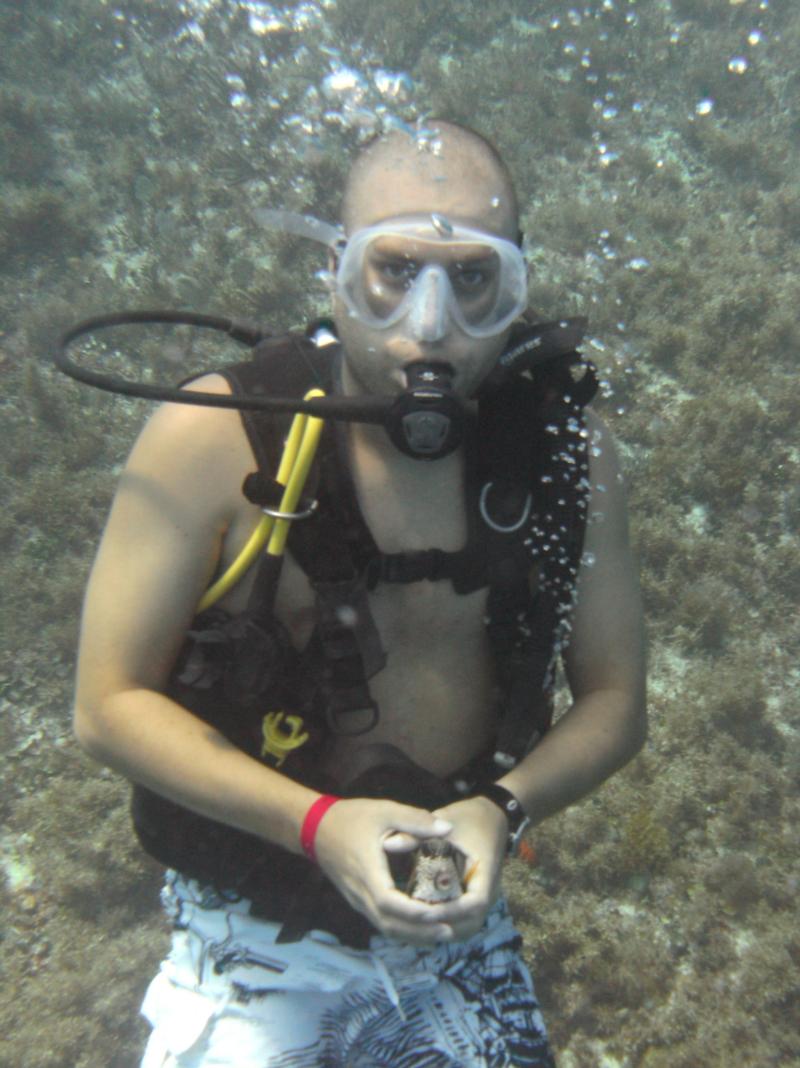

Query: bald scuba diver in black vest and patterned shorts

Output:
[75, 122, 646, 1068]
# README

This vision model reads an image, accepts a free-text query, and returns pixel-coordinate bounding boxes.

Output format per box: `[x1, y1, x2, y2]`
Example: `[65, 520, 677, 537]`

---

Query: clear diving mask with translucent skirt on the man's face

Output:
[335, 214, 528, 342]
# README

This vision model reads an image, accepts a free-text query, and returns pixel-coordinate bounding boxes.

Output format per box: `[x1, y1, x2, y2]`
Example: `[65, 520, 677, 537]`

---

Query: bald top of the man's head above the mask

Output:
[342, 120, 519, 241]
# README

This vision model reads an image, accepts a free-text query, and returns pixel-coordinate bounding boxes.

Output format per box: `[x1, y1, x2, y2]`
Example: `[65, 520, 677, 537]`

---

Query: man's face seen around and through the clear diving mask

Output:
[333, 137, 517, 396]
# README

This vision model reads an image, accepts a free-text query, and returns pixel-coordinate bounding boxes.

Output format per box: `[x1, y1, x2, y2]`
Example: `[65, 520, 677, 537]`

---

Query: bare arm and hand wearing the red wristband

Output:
[75, 379, 455, 942]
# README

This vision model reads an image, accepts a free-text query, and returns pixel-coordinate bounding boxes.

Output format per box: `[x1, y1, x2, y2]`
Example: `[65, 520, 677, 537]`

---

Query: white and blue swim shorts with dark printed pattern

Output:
[141, 873, 553, 1068]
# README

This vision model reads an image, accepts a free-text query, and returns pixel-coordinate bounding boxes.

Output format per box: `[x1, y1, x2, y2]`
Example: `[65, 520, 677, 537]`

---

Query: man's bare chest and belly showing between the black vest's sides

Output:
[218, 446, 493, 773]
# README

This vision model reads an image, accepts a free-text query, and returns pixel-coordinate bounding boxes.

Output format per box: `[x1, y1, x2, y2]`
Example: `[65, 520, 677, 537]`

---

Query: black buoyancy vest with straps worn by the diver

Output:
[132, 313, 596, 945]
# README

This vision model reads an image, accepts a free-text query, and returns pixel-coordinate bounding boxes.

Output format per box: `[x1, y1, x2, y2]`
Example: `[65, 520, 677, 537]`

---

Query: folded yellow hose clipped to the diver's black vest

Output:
[197, 390, 325, 612]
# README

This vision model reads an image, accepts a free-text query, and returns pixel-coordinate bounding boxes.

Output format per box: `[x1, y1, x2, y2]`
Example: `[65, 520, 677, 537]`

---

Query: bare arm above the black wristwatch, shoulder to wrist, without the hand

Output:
[500, 413, 646, 823]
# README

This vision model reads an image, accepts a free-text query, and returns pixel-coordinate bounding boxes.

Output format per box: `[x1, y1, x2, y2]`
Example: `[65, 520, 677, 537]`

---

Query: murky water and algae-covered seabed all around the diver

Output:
[0, 0, 800, 1068]
